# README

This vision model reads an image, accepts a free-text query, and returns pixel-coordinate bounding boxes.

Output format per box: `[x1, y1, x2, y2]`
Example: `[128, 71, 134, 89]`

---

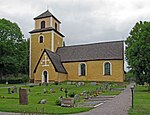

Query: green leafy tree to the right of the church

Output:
[125, 21, 150, 85]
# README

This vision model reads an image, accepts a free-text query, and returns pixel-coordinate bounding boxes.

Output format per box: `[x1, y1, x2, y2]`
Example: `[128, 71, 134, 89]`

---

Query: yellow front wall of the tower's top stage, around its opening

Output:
[35, 17, 50, 29]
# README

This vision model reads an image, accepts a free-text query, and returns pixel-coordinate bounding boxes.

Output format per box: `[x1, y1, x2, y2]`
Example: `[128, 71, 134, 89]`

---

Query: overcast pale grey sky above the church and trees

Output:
[0, 0, 150, 45]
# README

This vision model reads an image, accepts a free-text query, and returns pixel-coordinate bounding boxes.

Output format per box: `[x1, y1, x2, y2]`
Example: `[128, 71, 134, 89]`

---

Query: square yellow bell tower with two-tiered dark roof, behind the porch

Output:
[29, 10, 64, 82]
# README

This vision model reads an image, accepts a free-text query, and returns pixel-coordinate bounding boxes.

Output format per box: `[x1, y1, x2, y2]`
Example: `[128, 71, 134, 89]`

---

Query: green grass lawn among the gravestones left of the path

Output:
[0, 82, 124, 114]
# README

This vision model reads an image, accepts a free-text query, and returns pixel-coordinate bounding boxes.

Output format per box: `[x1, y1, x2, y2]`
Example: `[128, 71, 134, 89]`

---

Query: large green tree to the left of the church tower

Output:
[0, 19, 28, 76]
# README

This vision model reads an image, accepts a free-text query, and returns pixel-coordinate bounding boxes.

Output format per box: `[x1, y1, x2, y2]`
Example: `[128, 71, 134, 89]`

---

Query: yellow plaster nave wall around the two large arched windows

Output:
[63, 60, 124, 82]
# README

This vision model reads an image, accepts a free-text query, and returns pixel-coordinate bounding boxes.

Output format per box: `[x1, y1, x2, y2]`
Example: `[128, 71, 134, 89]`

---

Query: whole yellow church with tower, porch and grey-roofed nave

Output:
[29, 10, 124, 83]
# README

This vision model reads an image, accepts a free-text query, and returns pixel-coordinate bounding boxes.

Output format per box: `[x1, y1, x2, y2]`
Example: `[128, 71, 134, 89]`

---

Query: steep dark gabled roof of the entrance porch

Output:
[34, 49, 67, 74]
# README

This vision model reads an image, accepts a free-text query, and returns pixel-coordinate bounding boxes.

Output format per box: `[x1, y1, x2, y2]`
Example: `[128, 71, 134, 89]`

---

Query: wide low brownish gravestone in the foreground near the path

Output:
[61, 98, 74, 107]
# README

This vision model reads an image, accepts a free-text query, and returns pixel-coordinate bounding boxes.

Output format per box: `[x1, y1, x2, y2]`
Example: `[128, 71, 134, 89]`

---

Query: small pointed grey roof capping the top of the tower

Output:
[34, 10, 61, 23]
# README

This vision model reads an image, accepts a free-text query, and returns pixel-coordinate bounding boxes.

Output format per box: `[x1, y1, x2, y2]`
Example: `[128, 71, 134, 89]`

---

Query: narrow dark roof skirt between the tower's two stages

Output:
[29, 27, 65, 37]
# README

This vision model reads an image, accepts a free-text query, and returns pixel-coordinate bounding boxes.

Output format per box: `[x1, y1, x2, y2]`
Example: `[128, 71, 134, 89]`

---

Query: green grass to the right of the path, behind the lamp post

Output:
[129, 86, 150, 115]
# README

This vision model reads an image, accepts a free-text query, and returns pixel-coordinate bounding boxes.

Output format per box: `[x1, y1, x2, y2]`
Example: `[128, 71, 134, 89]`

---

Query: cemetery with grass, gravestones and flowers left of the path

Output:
[0, 82, 127, 114]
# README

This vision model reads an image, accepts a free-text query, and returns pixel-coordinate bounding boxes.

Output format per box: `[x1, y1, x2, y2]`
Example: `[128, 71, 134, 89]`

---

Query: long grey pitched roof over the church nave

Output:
[57, 41, 124, 62]
